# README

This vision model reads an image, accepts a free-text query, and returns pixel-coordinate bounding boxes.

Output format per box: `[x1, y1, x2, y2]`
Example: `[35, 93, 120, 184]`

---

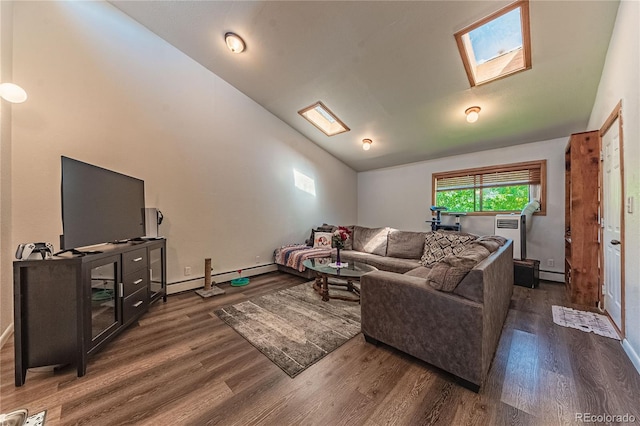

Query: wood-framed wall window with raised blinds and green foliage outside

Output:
[432, 160, 547, 215]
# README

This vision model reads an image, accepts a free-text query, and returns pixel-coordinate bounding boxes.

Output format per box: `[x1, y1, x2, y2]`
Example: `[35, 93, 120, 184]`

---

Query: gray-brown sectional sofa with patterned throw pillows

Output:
[276, 226, 513, 391]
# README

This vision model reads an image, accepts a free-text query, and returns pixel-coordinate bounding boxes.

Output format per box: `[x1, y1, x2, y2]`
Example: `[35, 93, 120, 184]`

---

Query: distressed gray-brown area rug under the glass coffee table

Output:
[214, 282, 360, 377]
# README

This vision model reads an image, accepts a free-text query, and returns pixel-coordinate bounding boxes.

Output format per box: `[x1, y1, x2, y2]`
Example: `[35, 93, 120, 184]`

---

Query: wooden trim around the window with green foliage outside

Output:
[431, 160, 547, 216]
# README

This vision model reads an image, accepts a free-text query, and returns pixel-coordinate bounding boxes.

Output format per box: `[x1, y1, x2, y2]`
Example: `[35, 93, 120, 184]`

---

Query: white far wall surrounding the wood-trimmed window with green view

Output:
[358, 137, 568, 281]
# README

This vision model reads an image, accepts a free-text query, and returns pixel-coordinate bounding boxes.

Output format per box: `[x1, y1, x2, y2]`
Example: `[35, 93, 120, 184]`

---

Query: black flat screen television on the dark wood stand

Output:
[60, 156, 145, 250]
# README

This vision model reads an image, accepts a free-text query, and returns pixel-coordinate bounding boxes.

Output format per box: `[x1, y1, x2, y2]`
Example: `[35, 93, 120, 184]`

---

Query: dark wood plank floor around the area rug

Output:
[0, 272, 640, 426]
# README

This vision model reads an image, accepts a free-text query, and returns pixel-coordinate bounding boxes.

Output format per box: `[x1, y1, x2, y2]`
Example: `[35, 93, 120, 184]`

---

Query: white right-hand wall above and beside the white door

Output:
[589, 1, 640, 371]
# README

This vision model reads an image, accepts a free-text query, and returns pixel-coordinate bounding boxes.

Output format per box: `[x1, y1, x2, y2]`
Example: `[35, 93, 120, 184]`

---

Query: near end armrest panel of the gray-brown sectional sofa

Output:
[360, 271, 483, 385]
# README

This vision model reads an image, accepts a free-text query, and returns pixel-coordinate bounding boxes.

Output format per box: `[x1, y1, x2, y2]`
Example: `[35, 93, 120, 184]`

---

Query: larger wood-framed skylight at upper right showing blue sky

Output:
[454, 0, 531, 87]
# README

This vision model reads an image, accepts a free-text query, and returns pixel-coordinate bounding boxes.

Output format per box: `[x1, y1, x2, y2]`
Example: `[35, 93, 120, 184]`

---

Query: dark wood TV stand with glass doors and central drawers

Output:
[13, 240, 167, 386]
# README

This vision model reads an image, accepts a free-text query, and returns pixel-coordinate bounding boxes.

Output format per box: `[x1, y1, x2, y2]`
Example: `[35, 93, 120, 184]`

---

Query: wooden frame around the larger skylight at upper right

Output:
[453, 0, 531, 87]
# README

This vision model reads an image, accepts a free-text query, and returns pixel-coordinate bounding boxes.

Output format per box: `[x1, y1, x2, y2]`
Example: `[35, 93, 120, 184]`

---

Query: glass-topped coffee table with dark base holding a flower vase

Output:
[302, 258, 377, 302]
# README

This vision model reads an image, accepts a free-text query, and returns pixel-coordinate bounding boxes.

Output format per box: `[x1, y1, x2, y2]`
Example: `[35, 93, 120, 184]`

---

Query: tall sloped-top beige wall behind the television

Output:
[10, 2, 357, 290]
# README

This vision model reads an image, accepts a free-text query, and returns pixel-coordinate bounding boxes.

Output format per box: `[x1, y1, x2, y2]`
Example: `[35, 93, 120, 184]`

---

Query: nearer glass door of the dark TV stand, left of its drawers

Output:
[91, 258, 120, 343]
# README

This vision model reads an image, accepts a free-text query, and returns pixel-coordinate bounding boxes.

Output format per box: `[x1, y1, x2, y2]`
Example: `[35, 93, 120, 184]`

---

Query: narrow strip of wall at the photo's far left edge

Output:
[0, 1, 14, 347]
